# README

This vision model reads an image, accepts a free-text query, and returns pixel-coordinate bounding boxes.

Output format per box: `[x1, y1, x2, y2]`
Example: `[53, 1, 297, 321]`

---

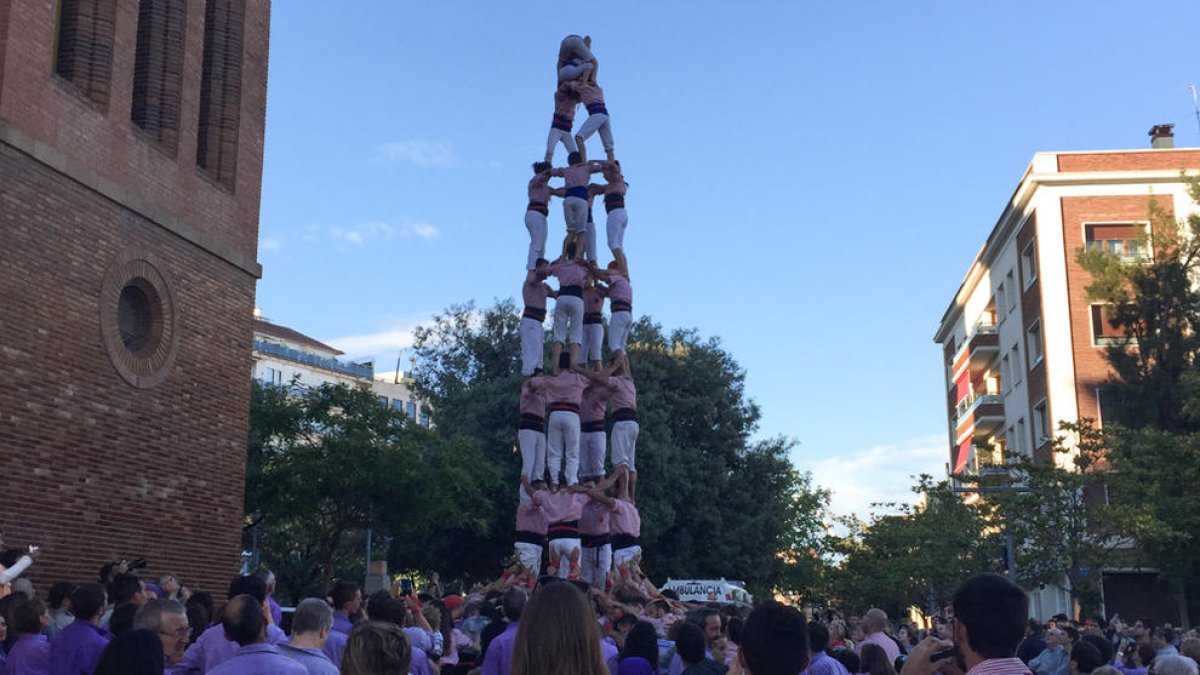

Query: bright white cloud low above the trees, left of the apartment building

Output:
[798, 435, 949, 519]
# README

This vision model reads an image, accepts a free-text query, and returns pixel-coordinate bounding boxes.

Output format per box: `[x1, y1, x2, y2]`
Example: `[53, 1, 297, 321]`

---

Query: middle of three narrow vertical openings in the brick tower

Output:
[130, 0, 187, 155]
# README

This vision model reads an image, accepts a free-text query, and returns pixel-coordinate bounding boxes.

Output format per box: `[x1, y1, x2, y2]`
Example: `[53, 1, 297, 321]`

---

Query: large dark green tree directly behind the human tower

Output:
[414, 300, 823, 592]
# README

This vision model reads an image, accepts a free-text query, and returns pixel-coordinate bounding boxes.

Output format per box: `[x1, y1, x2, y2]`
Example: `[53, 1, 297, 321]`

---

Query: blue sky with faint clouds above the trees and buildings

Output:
[258, 0, 1200, 512]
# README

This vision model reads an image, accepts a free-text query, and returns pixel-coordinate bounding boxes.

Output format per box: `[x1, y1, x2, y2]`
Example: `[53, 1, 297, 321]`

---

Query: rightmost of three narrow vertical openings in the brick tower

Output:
[196, 0, 246, 187]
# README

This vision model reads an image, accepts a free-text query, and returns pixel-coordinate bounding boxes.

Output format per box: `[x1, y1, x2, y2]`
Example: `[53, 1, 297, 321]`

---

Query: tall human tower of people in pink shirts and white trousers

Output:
[505, 35, 642, 589]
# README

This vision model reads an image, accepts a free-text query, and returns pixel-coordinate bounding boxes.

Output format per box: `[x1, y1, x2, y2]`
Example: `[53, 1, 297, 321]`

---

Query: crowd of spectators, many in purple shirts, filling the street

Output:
[0, 535, 1200, 675]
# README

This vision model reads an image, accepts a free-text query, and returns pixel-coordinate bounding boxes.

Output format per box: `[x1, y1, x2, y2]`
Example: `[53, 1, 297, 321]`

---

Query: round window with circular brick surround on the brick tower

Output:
[100, 257, 178, 388]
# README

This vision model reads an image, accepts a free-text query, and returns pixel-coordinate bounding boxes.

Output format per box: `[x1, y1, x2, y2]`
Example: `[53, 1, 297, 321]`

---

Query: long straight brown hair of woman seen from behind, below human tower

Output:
[511, 581, 608, 675]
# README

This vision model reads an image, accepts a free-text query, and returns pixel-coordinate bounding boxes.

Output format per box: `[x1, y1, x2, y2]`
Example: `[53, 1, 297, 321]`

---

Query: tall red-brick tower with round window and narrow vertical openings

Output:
[0, 0, 270, 592]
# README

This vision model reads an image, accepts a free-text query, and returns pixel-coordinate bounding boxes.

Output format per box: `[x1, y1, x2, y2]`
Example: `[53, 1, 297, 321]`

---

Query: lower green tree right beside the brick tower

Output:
[246, 382, 488, 592]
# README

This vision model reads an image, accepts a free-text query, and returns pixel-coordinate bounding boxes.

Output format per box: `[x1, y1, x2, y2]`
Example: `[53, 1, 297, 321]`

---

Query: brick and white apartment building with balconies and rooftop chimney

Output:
[934, 127, 1200, 619]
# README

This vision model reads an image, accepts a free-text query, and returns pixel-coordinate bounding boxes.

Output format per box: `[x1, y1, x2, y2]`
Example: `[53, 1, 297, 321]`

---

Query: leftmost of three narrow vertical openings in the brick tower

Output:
[54, 0, 116, 107]
